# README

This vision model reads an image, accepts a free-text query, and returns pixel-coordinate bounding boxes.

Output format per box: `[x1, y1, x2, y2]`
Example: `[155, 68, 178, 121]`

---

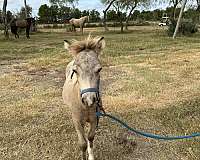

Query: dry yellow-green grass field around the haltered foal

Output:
[0, 27, 200, 160]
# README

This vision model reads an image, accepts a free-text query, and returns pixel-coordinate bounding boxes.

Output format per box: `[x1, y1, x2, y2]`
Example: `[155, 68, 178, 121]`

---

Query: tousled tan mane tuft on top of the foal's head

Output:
[69, 35, 105, 55]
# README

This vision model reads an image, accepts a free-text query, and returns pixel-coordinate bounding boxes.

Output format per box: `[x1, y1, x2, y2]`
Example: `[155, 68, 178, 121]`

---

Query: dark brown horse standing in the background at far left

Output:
[10, 18, 35, 38]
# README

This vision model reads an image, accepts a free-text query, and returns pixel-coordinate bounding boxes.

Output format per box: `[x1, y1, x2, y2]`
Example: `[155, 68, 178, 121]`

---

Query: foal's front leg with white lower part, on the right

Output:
[87, 116, 97, 160]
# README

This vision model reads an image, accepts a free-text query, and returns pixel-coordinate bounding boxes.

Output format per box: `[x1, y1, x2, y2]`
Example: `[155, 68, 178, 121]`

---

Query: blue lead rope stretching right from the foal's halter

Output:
[96, 112, 200, 140]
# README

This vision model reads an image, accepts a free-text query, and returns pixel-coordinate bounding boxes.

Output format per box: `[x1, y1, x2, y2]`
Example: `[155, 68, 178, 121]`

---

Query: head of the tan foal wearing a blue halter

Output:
[64, 36, 105, 107]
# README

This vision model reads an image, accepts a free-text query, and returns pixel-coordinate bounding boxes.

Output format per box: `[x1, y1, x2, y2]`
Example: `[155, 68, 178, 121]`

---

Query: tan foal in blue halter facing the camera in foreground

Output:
[62, 36, 105, 160]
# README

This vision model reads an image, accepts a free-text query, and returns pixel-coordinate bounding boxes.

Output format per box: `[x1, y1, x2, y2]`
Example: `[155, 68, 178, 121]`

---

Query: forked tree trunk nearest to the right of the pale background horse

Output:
[101, 0, 116, 31]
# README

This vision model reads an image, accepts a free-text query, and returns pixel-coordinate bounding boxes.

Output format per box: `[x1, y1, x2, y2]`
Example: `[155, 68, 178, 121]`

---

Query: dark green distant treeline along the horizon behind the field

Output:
[0, 4, 200, 24]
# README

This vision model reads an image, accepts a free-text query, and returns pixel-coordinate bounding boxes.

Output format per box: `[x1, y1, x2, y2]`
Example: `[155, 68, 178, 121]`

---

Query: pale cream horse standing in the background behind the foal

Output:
[69, 16, 89, 34]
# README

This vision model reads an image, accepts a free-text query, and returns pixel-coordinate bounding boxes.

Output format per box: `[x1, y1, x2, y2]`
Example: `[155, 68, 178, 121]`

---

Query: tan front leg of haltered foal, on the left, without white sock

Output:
[74, 120, 87, 160]
